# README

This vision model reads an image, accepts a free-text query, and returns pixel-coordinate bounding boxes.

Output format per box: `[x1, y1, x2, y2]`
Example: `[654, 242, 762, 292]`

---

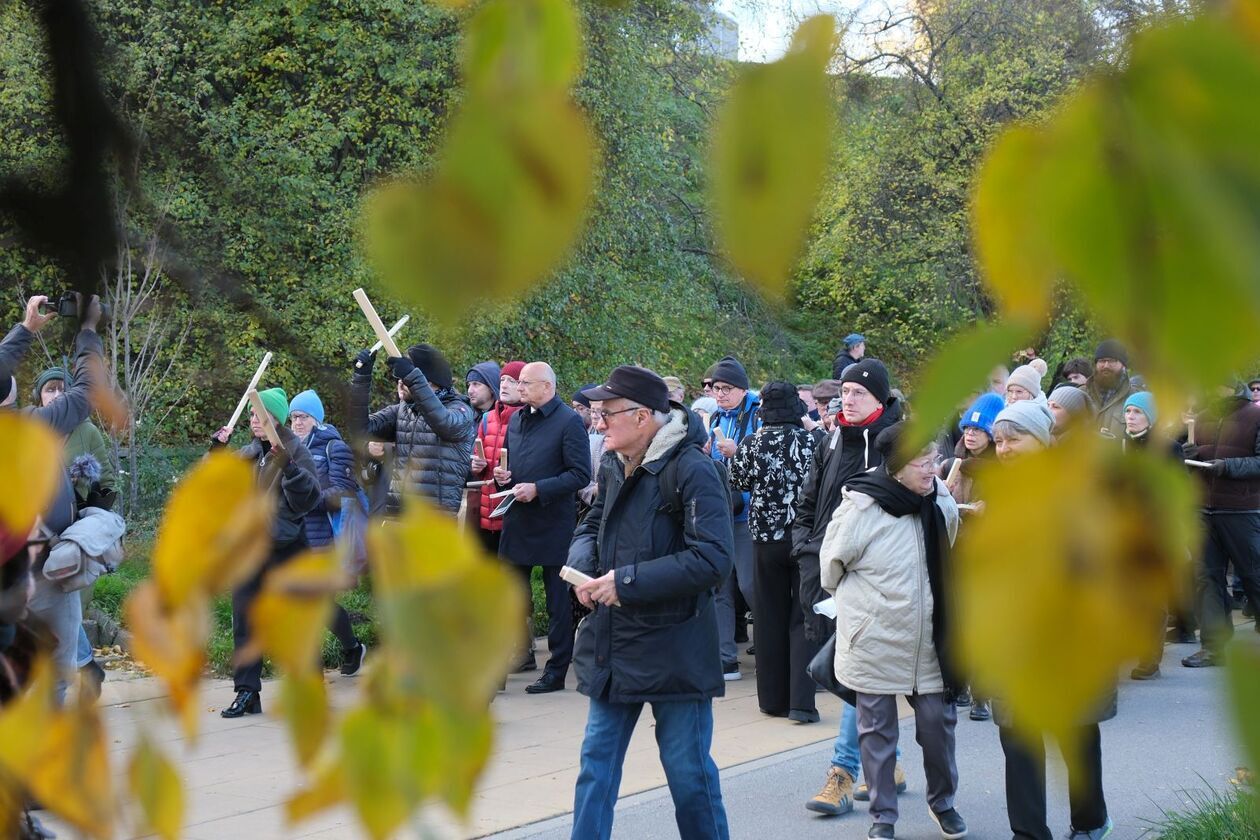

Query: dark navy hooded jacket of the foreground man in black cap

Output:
[568, 408, 735, 703]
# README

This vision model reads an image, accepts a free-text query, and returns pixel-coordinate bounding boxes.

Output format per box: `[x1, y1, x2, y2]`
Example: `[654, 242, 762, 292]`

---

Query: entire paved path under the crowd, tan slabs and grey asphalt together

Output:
[36, 623, 1250, 840]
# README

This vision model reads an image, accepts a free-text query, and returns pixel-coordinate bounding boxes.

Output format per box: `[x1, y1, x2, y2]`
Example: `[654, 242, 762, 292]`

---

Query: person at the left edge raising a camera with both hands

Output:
[0, 295, 105, 701]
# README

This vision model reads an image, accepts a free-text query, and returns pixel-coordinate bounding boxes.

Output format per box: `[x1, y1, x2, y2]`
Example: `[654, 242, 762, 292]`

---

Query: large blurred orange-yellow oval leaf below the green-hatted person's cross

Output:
[151, 452, 275, 607]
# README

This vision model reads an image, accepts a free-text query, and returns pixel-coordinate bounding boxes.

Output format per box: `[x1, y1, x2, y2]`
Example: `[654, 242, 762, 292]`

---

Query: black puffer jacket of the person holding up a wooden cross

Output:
[350, 368, 476, 515]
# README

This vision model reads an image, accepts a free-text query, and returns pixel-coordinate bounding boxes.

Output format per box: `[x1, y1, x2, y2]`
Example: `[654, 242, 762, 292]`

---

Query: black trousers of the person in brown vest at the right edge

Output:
[1194, 513, 1260, 650]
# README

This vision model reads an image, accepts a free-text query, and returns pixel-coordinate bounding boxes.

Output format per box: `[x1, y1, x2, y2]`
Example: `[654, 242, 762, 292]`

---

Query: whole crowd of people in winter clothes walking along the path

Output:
[0, 297, 1260, 840]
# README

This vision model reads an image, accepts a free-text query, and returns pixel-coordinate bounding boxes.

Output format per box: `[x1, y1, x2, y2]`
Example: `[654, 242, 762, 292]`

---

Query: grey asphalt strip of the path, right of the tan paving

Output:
[494, 637, 1252, 840]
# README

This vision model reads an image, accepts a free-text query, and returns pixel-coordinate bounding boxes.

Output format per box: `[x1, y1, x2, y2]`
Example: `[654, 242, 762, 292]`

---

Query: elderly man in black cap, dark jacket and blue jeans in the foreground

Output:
[568, 365, 735, 840]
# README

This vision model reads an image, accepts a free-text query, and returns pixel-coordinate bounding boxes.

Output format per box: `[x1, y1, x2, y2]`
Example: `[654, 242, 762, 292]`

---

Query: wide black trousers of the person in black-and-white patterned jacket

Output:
[752, 542, 819, 715]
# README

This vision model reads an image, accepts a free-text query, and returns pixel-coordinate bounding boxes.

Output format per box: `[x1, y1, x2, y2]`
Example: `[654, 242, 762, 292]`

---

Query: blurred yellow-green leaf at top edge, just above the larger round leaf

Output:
[464, 0, 582, 98]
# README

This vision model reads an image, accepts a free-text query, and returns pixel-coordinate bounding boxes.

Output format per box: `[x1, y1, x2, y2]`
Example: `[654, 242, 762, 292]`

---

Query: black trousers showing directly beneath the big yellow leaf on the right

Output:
[998, 723, 1106, 840]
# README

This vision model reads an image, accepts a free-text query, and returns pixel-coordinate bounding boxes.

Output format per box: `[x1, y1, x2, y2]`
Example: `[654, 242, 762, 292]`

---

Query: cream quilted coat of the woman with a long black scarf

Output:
[819, 479, 958, 694]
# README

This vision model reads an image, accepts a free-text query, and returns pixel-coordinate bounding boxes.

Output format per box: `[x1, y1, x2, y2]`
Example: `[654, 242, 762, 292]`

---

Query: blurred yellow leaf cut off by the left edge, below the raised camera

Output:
[0, 411, 63, 534]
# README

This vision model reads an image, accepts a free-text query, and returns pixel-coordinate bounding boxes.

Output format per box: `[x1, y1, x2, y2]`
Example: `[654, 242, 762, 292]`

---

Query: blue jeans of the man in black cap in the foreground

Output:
[572, 698, 730, 840]
